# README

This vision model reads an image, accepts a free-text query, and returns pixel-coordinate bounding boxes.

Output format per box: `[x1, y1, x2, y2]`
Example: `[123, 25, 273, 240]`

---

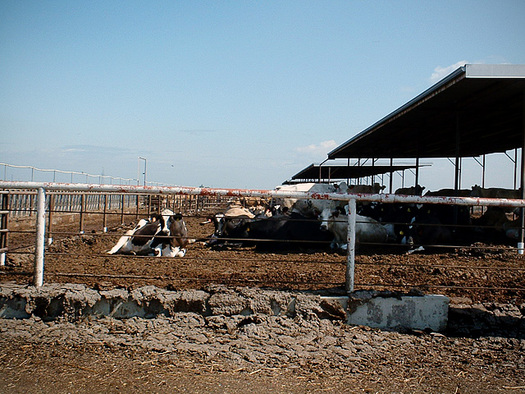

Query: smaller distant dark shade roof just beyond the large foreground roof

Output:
[292, 164, 421, 181]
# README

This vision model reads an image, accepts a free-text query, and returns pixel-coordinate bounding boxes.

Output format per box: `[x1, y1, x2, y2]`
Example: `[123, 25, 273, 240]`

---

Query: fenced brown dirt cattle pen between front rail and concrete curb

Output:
[0, 182, 525, 305]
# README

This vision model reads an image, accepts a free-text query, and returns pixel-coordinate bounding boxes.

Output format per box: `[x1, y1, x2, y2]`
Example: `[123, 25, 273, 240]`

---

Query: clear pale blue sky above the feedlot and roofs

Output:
[0, 0, 525, 189]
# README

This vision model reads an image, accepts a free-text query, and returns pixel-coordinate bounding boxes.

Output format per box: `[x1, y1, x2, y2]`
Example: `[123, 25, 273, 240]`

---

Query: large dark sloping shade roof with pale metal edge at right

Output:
[328, 64, 525, 159]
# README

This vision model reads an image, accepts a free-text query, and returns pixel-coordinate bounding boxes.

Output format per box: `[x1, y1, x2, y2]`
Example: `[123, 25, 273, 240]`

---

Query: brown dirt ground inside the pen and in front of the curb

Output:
[0, 217, 525, 393]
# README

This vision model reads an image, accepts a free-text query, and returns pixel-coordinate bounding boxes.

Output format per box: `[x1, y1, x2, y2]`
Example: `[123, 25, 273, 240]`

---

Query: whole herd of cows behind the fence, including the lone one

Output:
[108, 184, 520, 257]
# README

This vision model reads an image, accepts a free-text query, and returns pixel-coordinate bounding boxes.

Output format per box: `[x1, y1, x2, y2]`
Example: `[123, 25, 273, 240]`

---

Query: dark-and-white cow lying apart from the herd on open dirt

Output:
[108, 209, 191, 257]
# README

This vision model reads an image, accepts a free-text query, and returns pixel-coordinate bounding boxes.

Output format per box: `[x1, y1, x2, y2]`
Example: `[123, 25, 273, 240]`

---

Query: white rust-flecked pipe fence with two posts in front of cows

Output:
[0, 181, 525, 292]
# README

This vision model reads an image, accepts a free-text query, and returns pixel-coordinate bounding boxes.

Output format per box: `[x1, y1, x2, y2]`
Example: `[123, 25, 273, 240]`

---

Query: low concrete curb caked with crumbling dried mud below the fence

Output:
[0, 284, 448, 331]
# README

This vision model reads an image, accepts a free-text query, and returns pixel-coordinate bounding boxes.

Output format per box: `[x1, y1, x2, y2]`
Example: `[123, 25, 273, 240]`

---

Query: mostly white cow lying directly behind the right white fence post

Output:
[319, 208, 388, 250]
